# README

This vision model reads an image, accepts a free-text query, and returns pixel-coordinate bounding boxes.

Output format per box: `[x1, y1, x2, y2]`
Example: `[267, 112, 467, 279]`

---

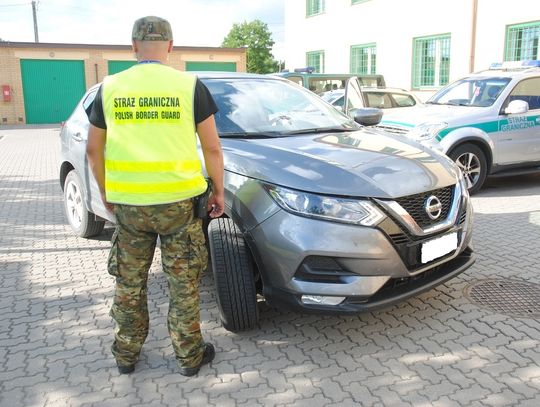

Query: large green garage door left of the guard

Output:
[21, 59, 86, 124]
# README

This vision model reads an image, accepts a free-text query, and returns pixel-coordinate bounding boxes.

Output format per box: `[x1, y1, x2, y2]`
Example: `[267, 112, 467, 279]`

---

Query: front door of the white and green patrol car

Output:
[494, 77, 540, 165]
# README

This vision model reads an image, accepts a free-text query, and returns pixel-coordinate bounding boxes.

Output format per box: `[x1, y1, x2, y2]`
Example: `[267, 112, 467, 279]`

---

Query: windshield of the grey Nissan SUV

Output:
[202, 78, 359, 137]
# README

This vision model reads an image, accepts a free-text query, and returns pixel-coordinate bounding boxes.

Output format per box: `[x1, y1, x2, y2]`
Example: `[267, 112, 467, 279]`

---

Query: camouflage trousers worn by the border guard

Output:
[108, 199, 208, 367]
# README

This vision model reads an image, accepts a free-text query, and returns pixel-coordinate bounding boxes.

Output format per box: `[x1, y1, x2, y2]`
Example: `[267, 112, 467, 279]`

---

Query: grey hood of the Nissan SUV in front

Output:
[222, 128, 458, 198]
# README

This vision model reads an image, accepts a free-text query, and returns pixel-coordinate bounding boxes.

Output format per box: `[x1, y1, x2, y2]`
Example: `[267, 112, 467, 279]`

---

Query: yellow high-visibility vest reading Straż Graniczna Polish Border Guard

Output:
[102, 63, 206, 205]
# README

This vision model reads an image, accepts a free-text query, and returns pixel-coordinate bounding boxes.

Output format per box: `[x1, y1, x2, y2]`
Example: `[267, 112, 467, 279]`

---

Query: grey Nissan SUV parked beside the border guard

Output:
[59, 73, 474, 331]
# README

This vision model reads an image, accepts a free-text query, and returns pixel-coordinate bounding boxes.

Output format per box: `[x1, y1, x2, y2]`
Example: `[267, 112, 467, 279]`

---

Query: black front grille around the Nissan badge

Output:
[396, 186, 454, 229]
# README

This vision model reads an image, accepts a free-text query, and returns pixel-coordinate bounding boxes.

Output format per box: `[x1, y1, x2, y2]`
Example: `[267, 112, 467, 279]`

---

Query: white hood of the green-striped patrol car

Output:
[380, 104, 490, 129]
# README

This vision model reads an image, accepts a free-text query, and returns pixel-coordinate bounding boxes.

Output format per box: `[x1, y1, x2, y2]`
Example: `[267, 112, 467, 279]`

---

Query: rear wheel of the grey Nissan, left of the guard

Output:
[64, 170, 105, 237]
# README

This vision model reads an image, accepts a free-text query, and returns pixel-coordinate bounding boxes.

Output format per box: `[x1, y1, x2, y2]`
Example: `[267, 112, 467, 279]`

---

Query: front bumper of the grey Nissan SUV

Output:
[245, 190, 475, 313]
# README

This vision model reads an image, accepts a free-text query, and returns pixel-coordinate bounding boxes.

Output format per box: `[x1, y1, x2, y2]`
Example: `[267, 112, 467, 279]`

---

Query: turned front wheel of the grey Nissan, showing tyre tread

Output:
[208, 218, 259, 332]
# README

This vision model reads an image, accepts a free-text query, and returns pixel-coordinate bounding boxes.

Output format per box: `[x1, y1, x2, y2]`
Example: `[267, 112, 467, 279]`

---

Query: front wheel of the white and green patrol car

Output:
[448, 143, 487, 195]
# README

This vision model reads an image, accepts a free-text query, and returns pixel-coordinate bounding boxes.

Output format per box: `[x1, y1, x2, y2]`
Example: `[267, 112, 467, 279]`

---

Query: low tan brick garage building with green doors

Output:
[0, 42, 246, 126]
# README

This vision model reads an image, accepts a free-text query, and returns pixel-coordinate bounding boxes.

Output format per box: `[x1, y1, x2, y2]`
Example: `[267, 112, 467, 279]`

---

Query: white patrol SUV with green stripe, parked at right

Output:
[378, 61, 540, 193]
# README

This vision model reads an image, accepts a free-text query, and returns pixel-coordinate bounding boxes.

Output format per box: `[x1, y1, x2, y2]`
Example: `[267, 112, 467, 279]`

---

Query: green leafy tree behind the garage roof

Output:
[221, 20, 278, 73]
